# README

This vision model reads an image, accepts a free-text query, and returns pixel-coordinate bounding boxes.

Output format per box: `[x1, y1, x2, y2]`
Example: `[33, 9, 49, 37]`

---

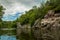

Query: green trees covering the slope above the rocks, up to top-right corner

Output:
[17, 0, 60, 26]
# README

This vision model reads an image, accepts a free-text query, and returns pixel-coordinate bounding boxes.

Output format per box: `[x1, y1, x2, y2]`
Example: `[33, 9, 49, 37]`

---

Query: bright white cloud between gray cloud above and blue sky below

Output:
[5, 3, 29, 14]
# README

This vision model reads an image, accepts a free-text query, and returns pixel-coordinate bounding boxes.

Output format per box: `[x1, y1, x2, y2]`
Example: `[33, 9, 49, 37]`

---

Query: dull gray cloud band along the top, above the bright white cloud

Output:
[0, 0, 42, 7]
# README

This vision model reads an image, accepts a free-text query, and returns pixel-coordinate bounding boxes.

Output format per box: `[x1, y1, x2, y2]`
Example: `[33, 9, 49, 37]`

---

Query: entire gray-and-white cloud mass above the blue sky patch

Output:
[0, 0, 41, 14]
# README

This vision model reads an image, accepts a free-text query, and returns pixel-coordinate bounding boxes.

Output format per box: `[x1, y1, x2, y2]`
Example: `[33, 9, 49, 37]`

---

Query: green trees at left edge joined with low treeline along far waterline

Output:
[0, 5, 16, 28]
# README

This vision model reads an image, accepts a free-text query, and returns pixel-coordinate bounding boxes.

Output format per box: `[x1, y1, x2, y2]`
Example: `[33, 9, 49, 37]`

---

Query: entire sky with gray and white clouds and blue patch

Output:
[0, 0, 46, 21]
